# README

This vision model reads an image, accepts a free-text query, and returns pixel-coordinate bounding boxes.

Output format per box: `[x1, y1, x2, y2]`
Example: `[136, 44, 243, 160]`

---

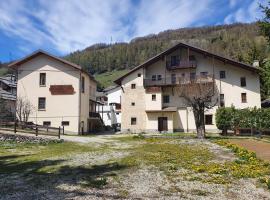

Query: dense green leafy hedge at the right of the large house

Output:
[216, 107, 270, 133]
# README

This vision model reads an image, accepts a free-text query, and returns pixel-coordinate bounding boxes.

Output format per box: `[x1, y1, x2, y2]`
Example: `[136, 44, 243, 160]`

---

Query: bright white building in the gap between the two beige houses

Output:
[96, 86, 121, 126]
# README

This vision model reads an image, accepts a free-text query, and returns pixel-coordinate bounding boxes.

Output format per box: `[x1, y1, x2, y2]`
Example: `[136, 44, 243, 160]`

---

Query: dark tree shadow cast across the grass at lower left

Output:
[0, 155, 127, 199]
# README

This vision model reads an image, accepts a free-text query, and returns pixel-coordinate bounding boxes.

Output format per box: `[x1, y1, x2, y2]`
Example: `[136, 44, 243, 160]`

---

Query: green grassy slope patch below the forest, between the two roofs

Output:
[95, 69, 129, 88]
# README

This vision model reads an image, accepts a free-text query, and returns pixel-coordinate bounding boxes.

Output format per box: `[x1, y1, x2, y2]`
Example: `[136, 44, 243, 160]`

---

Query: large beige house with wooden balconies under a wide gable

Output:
[115, 43, 261, 132]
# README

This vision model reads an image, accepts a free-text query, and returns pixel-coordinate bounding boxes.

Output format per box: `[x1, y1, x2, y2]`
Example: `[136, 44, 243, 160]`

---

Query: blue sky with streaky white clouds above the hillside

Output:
[0, 0, 266, 62]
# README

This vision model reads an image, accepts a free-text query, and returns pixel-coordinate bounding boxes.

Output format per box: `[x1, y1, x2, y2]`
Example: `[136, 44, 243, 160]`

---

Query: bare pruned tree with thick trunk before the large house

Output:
[178, 75, 218, 138]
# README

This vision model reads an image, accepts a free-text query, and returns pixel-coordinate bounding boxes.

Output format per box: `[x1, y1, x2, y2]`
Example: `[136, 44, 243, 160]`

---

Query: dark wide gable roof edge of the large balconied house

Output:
[114, 42, 259, 85]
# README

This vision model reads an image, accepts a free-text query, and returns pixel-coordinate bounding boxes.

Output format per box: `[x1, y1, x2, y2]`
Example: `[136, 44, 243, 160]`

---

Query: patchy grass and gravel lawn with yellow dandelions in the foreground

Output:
[0, 134, 270, 199]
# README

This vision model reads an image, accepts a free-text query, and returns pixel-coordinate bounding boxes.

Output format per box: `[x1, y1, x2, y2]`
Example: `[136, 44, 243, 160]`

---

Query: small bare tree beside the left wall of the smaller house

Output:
[16, 97, 34, 123]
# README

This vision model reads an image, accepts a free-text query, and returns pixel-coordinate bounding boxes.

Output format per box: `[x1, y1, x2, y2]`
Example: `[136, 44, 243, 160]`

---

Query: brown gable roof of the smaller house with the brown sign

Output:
[8, 49, 97, 82]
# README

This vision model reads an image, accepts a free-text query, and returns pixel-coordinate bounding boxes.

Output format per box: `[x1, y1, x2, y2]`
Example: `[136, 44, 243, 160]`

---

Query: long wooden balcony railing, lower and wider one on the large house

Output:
[144, 75, 214, 87]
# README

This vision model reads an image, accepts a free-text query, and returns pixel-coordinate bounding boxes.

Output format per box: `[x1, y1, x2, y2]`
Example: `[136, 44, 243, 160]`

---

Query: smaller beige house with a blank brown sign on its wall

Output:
[10, 50, 97, 134]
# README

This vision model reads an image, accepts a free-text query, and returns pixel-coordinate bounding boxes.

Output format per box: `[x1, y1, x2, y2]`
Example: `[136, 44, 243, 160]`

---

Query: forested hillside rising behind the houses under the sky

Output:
[66, 23, 268, 79]
